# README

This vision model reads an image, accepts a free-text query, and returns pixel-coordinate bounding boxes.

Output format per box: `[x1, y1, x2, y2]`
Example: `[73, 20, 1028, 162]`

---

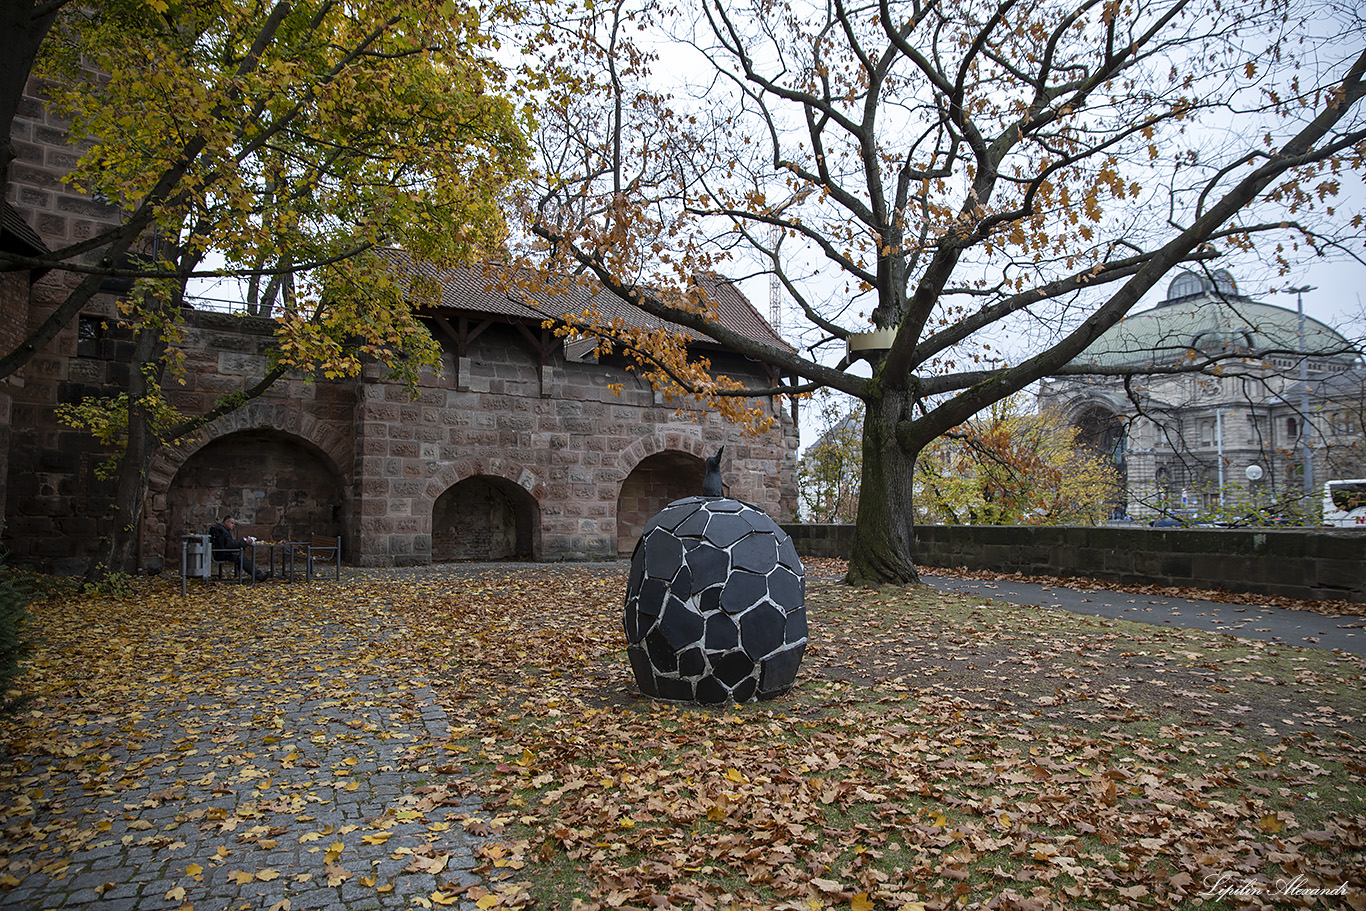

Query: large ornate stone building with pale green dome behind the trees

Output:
[1040, 270, 1366, 520]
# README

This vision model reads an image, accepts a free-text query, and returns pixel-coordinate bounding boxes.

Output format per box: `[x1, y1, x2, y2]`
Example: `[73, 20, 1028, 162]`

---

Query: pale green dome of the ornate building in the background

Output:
[1075, 269, 1355, 372]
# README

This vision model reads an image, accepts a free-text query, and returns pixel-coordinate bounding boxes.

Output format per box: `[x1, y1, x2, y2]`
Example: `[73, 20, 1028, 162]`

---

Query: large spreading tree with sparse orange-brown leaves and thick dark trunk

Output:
[522, 0, 1366, 585]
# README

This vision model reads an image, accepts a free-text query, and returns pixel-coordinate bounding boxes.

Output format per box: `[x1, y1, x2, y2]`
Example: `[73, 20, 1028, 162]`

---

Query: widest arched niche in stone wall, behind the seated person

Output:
[161, 430, 346, 565]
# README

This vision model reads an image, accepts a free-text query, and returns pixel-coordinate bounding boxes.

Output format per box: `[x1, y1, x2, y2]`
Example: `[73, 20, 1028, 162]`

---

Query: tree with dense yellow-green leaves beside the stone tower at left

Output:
[0, 0, 527, 576]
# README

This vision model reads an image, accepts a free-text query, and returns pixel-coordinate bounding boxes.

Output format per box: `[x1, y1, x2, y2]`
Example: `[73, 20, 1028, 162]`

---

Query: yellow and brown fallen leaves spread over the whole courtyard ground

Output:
[0, 565, 1366, 911]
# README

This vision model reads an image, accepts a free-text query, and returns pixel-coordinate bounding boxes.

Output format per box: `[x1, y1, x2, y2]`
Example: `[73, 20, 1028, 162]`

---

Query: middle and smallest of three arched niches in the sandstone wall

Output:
[432, 475, 541, 563]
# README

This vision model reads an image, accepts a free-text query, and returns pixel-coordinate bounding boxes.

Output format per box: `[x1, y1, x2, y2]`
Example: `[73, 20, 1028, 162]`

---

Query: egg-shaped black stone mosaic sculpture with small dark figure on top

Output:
[623, 452, 806, 703]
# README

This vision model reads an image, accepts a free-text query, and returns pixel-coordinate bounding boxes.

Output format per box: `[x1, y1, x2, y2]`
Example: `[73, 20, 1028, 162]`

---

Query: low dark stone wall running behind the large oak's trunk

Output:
[783, 524, 1366, 604]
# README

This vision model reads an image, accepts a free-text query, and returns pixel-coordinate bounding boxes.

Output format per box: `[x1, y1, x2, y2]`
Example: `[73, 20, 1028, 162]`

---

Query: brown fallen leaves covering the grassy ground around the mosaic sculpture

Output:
[379, 570, 1366, 910]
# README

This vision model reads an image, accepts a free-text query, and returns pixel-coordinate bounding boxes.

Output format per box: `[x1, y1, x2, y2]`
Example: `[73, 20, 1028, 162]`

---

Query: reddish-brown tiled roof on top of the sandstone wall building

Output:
[388, 251, 792, 351]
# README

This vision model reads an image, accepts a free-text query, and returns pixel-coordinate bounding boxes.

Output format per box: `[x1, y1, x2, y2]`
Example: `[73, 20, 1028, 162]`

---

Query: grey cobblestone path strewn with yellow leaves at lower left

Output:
[0, 580, 485, 911]
